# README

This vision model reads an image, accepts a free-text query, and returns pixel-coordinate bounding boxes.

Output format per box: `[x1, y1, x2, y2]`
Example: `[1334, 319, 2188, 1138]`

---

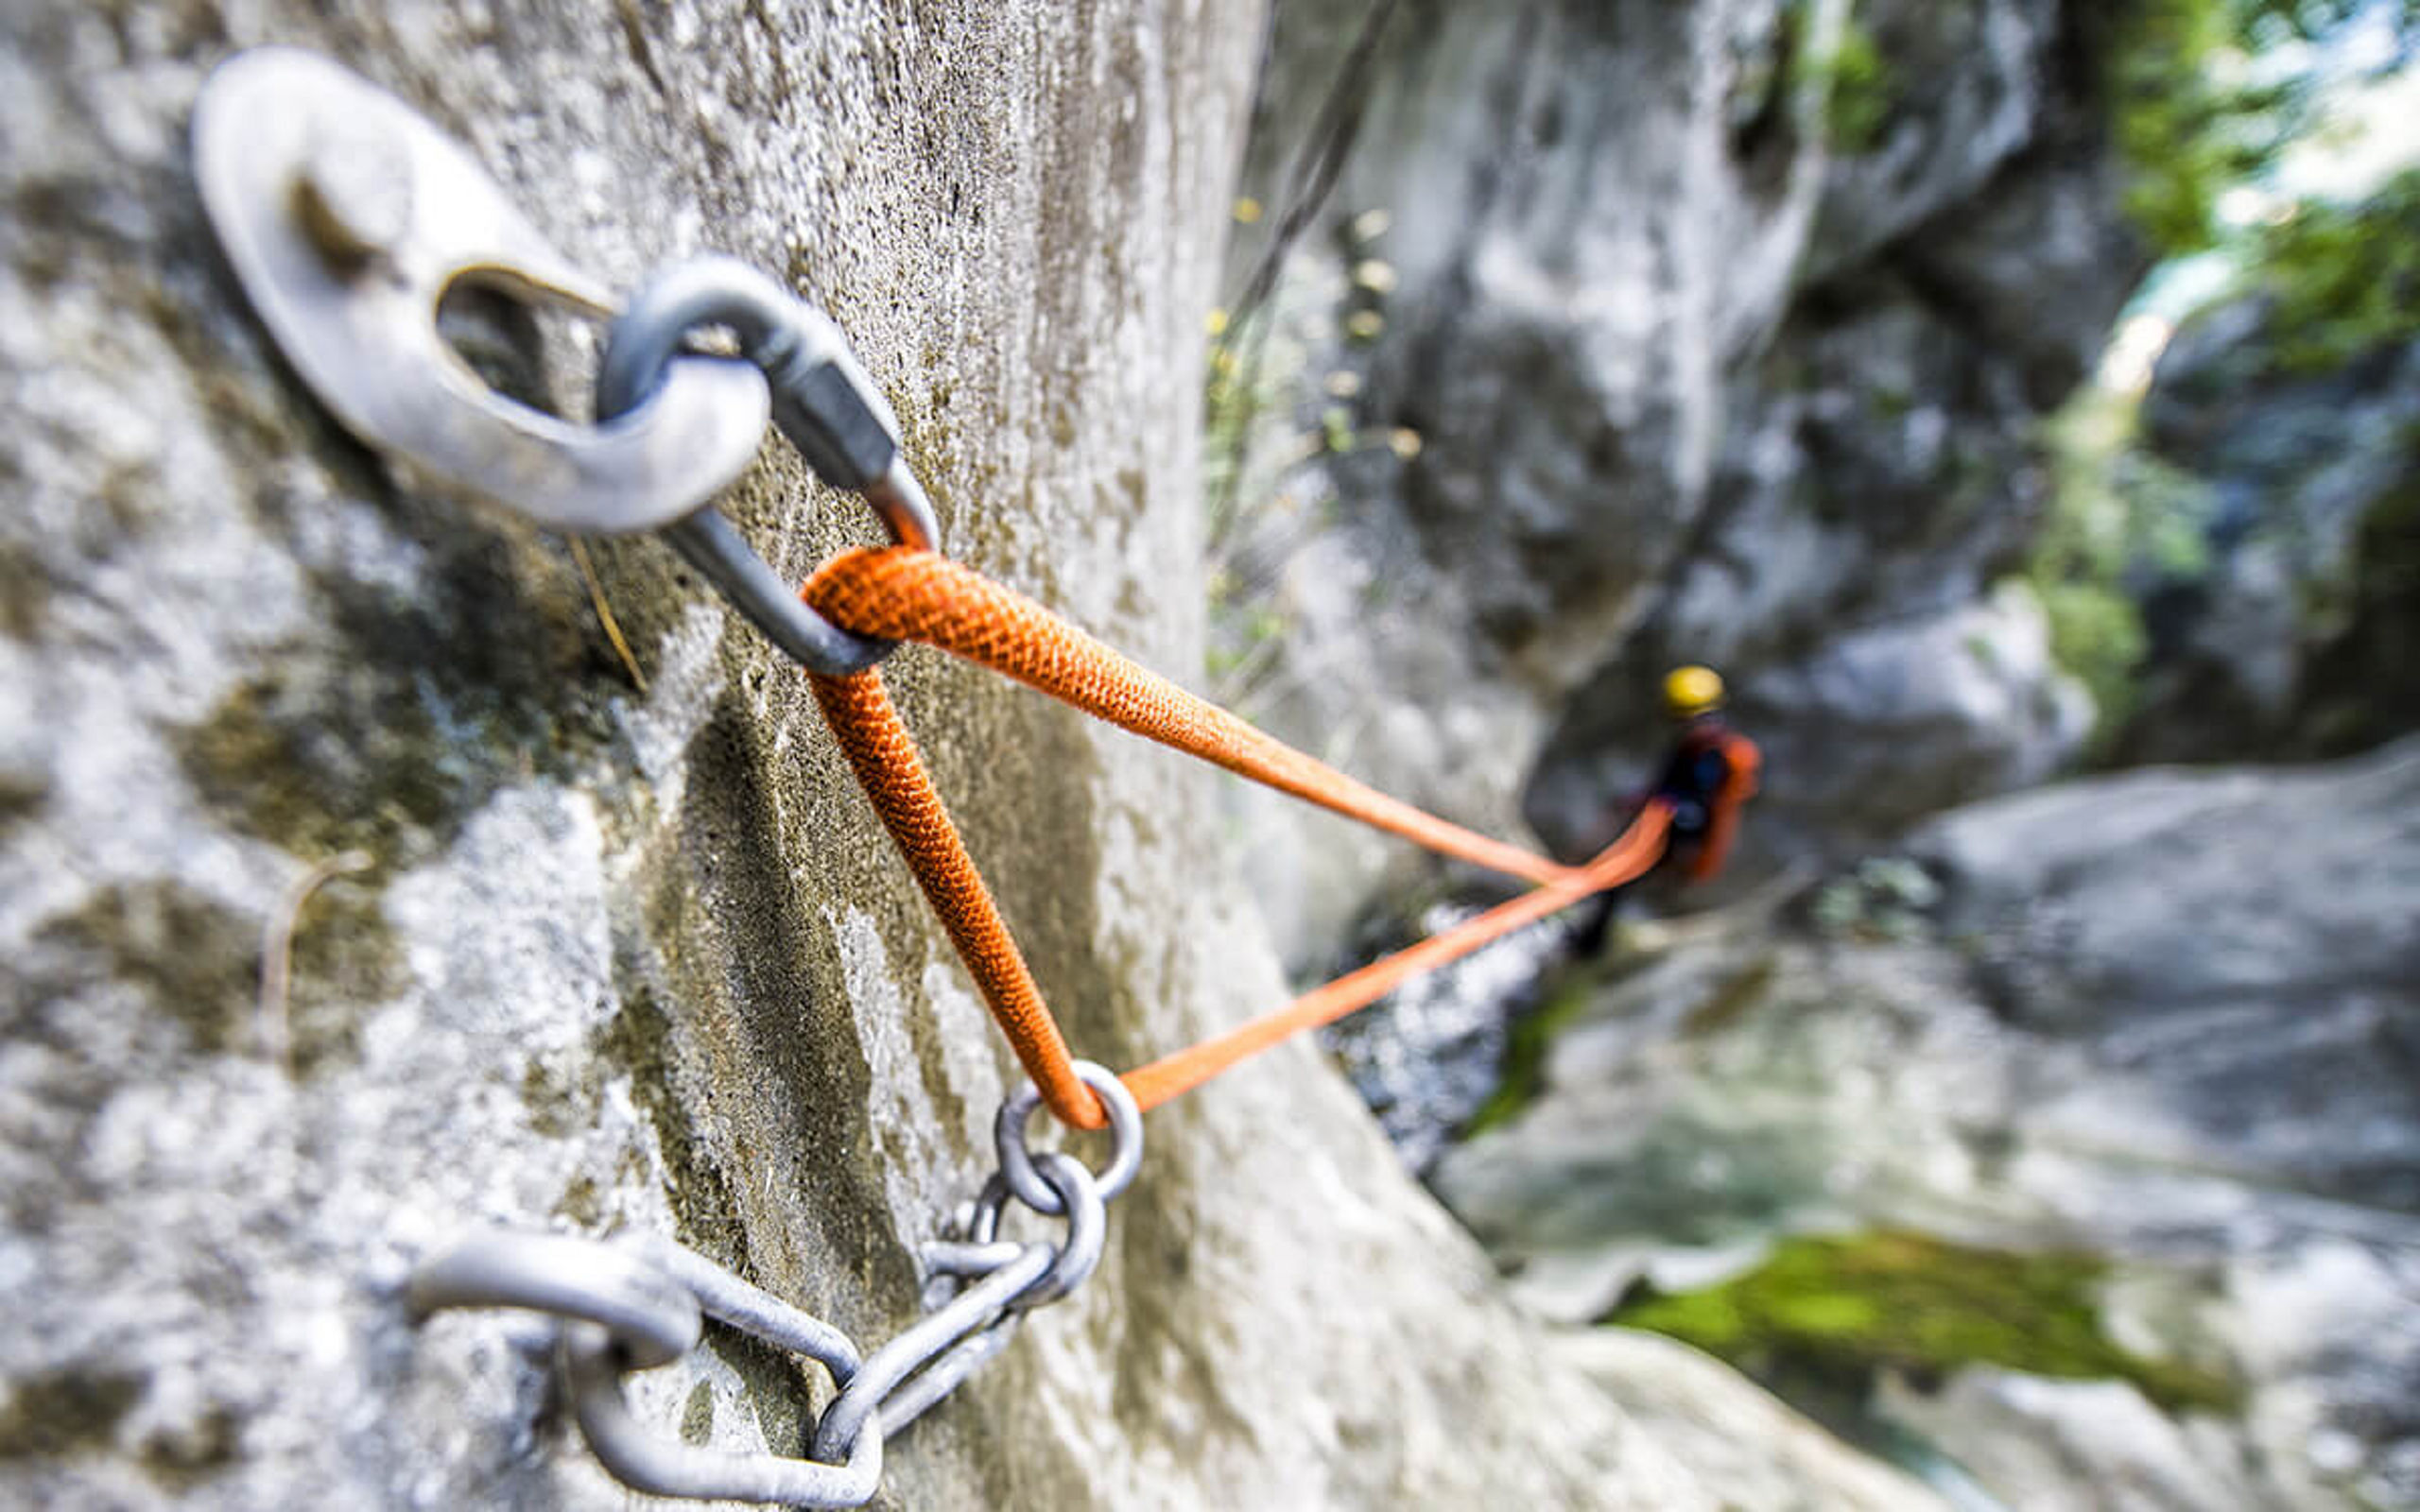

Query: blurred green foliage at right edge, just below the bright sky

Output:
[2248, 169, 2420, 372]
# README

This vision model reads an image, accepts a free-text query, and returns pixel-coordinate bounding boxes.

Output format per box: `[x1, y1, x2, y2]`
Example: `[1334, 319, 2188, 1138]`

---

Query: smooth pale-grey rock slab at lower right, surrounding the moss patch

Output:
[1438, 743, 2420, 1507]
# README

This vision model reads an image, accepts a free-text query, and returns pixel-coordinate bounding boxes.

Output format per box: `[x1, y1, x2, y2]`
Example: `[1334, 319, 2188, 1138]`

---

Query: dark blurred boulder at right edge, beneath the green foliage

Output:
[2113, 298, 2420, 762]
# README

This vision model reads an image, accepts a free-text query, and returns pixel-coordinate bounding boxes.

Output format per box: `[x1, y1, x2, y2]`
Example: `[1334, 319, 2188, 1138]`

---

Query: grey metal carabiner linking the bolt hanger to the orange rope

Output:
[597, 256, 942, 675]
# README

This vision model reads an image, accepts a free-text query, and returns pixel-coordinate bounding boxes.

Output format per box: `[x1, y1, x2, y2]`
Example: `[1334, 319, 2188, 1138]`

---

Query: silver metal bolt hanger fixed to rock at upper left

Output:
[194, 48, 772, 535]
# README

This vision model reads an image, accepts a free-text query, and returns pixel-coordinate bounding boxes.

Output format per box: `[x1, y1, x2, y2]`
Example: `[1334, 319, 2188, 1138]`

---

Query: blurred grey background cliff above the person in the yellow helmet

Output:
[1210, 0, 2142, 943]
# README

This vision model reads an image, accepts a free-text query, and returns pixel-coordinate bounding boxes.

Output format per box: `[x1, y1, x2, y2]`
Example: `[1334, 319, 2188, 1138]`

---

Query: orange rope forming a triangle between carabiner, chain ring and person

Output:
[801, 547, 1669, 1127]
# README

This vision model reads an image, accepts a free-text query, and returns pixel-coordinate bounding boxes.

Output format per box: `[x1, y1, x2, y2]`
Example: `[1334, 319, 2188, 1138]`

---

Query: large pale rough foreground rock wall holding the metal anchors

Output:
[0, 0, 1922, 1507]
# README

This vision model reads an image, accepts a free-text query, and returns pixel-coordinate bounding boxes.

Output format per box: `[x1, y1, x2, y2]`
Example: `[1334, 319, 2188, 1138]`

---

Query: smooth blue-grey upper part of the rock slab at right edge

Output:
[1910, 743, 2420, 1212]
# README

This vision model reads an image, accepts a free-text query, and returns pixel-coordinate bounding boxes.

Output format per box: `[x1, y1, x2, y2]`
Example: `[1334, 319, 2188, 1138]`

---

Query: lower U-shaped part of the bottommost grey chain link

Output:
[562, 1323, 883, 1507]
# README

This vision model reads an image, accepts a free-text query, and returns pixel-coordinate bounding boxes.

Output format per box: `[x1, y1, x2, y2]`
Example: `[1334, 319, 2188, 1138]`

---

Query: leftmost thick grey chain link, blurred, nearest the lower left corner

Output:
[405, 1231, 704, 1369]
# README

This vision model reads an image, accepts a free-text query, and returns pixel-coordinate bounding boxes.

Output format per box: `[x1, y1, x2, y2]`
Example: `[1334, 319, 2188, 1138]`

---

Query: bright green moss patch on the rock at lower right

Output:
[1604, 1231, 2241, 1413]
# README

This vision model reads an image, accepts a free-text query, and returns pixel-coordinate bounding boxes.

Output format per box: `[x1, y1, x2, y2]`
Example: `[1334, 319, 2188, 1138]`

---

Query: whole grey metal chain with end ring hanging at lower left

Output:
[405, 1062, 1142, 1507]
